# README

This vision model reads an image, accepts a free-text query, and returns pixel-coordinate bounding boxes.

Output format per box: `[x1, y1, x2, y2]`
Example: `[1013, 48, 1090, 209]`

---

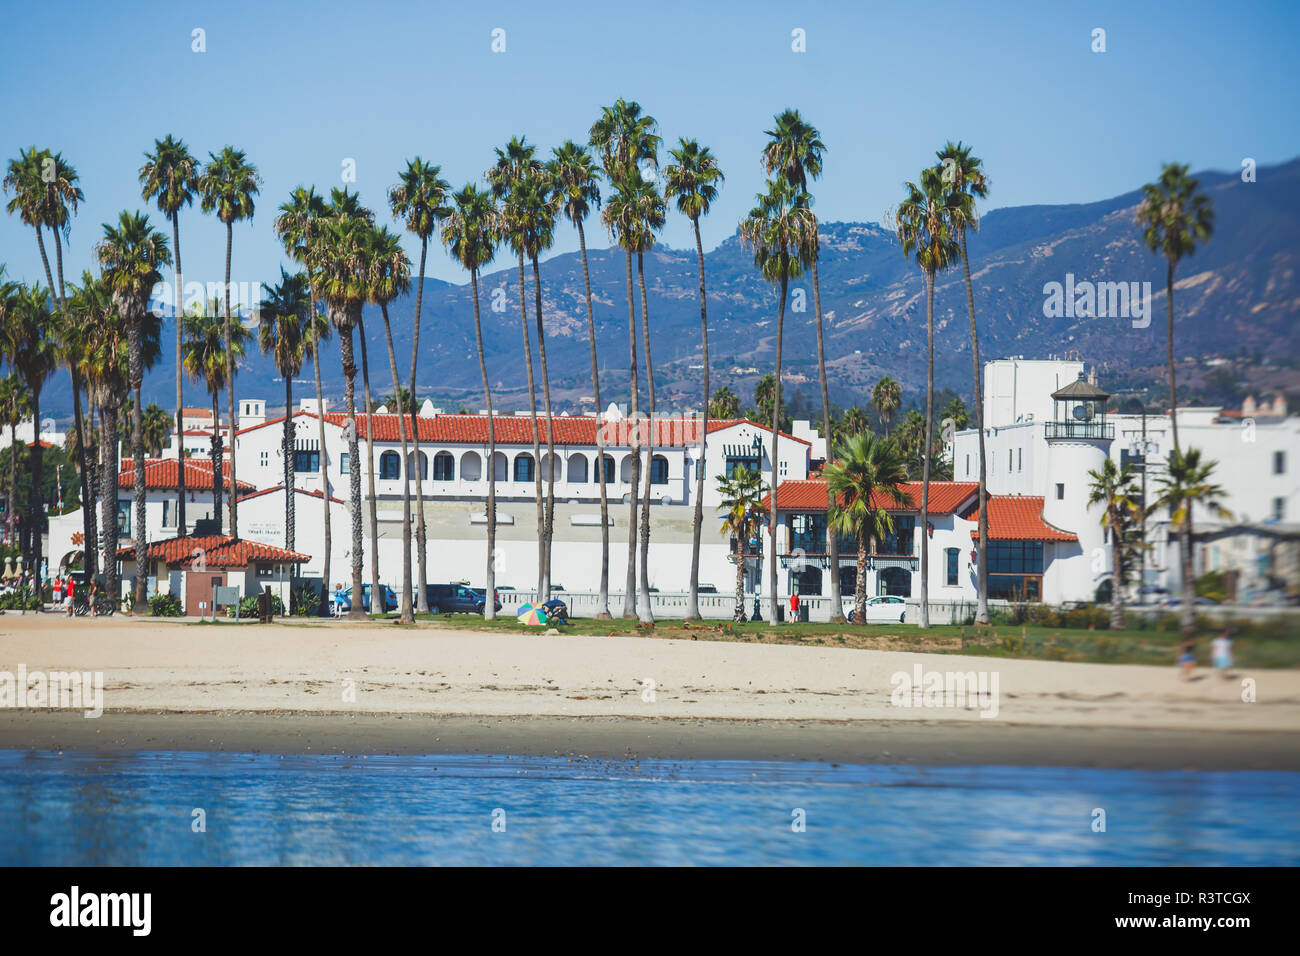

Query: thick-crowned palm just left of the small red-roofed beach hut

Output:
[95, 212, 170, 614]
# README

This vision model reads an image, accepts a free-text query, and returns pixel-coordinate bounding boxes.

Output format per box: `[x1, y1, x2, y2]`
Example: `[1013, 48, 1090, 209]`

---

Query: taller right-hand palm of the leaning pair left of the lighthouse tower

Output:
[935, 140, 989, 624]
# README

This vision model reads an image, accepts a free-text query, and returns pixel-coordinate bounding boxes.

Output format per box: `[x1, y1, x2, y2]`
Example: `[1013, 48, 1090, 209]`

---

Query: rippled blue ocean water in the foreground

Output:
[0, 750, 1300, 866]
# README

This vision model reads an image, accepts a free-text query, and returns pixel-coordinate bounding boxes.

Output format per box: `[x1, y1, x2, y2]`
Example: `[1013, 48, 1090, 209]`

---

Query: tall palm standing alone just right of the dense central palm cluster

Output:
[665, 139, 727, 620]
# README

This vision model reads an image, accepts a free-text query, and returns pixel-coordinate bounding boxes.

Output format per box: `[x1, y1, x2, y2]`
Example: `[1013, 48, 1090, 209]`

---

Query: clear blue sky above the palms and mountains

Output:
[0, 0, 1300, 295]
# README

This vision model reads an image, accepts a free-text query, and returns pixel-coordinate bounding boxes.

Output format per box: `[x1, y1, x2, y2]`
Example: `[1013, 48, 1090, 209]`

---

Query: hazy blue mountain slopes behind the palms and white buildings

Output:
[32, 160, 1300, 414]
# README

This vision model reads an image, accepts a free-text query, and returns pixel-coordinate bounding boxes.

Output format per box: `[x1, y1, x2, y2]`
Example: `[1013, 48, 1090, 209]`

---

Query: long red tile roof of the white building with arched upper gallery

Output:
[237, 410, 810, 447]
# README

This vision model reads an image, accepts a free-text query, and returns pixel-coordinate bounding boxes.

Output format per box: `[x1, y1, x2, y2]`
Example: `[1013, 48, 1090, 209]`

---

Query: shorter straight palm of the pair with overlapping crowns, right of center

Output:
[740, 178, 811, 627]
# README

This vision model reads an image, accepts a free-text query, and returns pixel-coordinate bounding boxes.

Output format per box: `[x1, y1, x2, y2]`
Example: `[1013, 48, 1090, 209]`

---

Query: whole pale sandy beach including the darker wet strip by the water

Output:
[0, 613, 1300, 769]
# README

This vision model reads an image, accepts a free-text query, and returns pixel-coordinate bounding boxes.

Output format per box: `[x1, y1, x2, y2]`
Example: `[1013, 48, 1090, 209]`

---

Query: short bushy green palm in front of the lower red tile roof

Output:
[826, 432, 913, 624]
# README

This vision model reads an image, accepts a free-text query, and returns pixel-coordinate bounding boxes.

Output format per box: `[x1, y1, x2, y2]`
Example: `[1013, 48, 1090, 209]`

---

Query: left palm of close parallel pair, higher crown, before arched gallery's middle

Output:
[488, 137, 546, 601]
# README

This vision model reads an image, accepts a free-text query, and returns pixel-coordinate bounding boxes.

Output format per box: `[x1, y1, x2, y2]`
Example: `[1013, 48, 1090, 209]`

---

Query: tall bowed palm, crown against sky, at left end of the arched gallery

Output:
[389, 156, 451, 614]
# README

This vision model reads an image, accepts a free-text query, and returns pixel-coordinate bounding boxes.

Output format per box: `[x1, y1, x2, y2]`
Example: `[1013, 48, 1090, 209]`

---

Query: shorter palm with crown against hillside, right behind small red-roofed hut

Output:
[257, 268, 319, 551]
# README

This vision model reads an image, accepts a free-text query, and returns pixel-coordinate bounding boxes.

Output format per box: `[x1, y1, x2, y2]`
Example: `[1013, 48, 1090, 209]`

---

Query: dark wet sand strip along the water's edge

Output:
[0, 710, 1300, 771]
